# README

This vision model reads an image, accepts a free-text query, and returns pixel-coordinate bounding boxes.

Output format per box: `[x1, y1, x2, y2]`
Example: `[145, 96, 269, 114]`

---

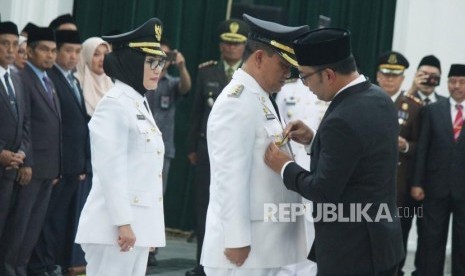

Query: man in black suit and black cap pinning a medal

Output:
[265, 28, 404, 276]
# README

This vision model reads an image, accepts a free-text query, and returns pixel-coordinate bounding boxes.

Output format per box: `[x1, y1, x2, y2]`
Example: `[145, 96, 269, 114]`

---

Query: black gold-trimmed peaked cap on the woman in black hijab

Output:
[102, 17, 166, 57]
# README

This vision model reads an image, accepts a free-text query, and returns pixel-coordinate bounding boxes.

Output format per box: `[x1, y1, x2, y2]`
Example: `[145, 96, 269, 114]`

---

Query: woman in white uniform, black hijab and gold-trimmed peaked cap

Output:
[76, 18, 166, 276]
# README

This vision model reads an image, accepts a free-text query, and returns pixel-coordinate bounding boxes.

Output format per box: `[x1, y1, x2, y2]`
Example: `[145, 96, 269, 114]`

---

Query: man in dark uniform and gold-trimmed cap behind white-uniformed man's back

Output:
[186, 19, 249, 276]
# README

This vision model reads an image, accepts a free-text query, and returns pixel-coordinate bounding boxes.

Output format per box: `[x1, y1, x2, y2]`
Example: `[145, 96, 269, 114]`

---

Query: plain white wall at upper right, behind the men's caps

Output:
[392, 0, 465, 96]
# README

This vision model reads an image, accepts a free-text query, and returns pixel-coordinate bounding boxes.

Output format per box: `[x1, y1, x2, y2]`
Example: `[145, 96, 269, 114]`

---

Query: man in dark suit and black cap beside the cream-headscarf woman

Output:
[29, 30, 90, 272]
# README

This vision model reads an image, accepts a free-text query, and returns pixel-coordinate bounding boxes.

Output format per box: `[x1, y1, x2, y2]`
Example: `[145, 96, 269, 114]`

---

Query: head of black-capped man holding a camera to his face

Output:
[407, 55, 446, 105]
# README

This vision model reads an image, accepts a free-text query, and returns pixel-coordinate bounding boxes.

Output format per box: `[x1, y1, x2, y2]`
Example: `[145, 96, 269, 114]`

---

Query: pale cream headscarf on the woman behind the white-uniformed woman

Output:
[75, 37, 113, 116]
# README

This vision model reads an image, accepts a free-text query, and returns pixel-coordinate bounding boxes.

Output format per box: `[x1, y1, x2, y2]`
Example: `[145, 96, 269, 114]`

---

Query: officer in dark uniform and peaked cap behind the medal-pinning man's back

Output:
[376, 51, 423, 275]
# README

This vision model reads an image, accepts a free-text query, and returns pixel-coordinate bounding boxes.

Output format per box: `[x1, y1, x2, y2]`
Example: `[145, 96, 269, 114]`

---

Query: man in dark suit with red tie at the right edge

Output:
[411, 64, 465, 275]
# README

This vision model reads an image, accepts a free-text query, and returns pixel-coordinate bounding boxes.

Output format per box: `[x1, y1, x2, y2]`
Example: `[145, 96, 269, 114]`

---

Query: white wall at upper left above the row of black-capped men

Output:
[0, 0, 74, 31]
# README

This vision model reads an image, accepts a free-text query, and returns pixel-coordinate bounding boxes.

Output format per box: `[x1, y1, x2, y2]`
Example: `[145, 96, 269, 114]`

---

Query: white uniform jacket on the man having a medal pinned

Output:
[201, 69, 307, 268]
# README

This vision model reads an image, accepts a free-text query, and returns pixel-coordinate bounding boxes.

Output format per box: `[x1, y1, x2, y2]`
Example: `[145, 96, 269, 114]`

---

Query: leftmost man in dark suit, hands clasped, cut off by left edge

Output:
[0, 22, 31, 242]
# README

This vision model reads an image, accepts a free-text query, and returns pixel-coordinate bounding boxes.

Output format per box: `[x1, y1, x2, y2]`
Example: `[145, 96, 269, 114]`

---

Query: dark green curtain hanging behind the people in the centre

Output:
[74, 0, 396, 230]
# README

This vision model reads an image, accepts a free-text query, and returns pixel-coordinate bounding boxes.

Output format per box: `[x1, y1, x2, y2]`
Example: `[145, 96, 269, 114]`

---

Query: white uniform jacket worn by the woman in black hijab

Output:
[76, 81, 165, 247]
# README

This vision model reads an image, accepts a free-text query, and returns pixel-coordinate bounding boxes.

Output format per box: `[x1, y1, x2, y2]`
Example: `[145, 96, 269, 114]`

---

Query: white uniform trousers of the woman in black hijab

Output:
[81, 243, 149, 276]
